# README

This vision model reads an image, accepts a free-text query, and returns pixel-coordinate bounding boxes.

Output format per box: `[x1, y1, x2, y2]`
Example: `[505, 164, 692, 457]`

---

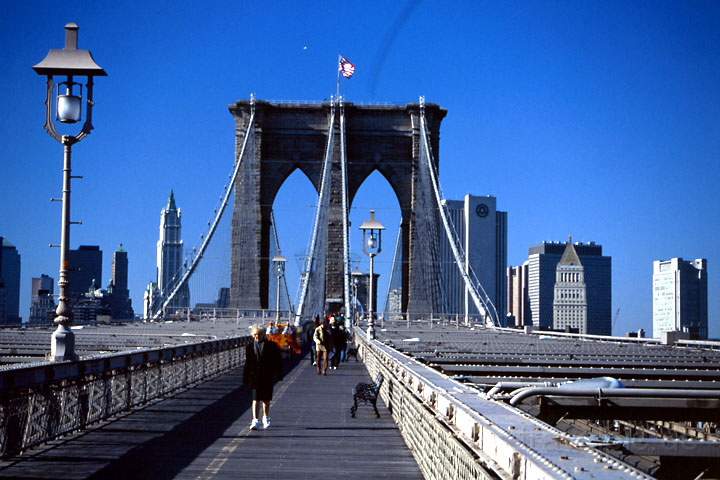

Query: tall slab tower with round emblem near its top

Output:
[439, 195, 507, 321]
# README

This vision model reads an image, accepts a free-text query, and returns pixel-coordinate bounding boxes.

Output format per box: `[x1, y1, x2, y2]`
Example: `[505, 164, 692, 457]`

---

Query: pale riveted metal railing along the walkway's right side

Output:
[355, 329, 651, 480]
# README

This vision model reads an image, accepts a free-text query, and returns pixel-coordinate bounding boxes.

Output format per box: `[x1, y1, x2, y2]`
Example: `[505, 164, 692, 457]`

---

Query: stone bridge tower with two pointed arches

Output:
[230, 101, 447, 313]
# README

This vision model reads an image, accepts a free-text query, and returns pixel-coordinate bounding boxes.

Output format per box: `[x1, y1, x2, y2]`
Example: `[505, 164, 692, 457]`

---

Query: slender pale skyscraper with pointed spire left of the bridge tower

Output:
[157, 191, 190, 308]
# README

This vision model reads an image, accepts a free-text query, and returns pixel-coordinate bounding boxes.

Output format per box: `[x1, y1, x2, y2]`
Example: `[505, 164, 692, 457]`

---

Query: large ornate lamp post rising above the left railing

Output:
[33, 23, 107, 361]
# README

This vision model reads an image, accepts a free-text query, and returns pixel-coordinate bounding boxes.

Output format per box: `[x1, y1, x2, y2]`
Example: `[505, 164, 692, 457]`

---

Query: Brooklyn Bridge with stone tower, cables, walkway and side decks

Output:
[0, 97, 720, 479]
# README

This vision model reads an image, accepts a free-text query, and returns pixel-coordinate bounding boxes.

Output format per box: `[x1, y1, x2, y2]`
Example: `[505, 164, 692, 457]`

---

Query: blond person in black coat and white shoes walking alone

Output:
[243, 325, 282, 430]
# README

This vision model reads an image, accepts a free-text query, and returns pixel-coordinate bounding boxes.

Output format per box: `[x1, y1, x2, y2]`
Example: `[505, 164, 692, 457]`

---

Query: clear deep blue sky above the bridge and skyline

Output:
[0, 1, 720, 336]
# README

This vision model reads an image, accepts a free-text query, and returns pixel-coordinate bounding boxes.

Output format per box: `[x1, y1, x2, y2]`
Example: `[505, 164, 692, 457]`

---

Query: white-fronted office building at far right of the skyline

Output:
[653, 258, 708, 339]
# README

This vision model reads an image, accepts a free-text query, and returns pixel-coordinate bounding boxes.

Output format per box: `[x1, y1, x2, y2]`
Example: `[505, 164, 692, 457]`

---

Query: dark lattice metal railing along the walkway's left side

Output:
[0, 336, 250, 457]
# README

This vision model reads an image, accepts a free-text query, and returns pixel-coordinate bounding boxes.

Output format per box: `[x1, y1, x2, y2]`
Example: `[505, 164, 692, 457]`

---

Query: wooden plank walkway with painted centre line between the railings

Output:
[0, 359, 422, 480]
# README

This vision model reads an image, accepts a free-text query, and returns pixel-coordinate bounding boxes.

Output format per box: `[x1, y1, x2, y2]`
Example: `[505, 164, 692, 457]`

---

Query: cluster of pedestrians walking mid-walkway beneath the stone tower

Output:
[310, 315, 350, 375]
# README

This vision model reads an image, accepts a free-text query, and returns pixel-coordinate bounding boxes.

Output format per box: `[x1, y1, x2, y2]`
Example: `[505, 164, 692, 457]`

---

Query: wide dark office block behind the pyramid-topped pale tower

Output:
[519, 242, 612, 335]
